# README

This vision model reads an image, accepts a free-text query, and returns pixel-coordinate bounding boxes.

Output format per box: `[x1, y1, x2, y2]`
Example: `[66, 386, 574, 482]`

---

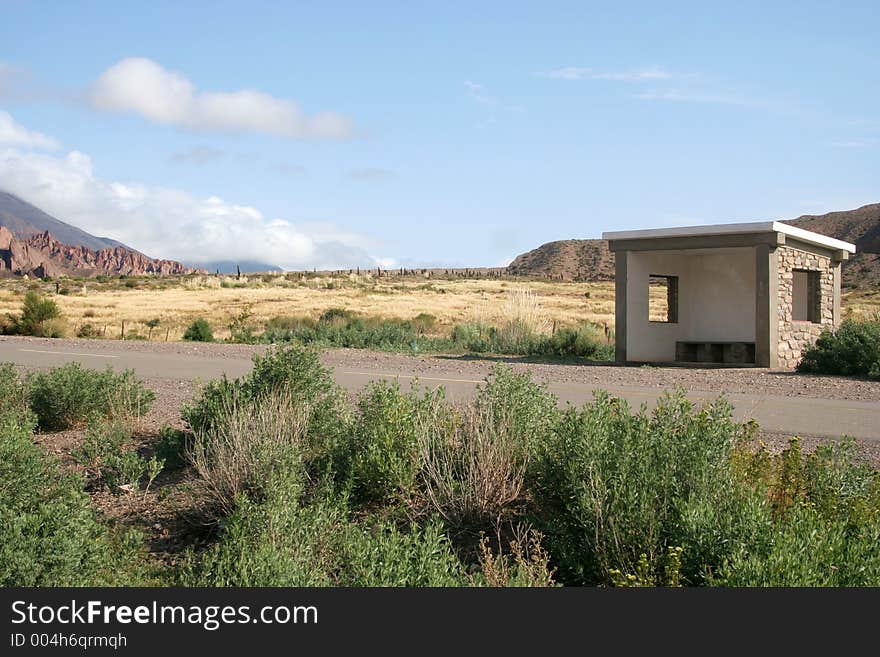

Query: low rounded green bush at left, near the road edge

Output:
[26, 362, 155, 431]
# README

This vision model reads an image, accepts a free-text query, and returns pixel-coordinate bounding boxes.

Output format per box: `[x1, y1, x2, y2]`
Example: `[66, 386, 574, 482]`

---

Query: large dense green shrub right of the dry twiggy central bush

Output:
[531, 391, 765, 584]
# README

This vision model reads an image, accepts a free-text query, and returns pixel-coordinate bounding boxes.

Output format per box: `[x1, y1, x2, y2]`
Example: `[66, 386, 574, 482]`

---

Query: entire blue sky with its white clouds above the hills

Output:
[0, 0, 880, 268]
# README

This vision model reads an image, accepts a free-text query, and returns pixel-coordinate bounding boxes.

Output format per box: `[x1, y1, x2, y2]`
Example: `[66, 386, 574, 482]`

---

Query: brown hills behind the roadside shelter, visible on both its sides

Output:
[506, 203, 880, 288]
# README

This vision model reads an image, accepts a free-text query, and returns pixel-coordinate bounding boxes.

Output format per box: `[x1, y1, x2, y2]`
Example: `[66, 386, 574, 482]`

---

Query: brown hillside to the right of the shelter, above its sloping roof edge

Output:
[785, 203, 880, 288]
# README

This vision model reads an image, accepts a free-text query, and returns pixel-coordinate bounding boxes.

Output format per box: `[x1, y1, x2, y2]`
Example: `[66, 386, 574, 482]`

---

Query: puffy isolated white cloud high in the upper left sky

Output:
[89, 57, 352, 139]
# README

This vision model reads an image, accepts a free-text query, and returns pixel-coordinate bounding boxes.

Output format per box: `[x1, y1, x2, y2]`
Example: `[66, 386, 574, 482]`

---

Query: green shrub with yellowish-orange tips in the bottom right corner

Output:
[717, 438, 880, 586]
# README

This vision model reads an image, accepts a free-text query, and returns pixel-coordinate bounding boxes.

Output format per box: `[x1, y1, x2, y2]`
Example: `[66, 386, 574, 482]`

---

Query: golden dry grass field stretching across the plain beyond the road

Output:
[0, 273, 880, 340]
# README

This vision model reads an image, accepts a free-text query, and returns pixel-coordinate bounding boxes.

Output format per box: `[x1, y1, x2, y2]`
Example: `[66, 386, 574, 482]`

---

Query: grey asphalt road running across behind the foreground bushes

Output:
[0, 340, 880, 442]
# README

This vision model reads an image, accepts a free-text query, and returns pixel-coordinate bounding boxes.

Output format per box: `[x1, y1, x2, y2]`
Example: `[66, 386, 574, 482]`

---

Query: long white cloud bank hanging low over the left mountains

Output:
[0, 142, 385, 269]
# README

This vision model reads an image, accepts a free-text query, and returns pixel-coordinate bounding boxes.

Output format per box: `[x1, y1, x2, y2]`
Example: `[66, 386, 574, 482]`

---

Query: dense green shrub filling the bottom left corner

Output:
[0, 412, 145, 587]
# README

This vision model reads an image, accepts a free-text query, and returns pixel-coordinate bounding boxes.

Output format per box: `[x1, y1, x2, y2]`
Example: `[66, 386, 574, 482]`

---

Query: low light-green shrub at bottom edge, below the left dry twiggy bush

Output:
[181, 480, 467, 586]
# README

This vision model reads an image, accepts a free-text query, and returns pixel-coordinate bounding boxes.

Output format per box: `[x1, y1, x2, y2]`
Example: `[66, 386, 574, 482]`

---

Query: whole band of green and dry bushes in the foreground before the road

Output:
[0, 345, 880, 586]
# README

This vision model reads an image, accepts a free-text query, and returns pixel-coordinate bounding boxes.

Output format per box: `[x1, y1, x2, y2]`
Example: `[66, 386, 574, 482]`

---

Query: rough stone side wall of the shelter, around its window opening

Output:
[776, 246, 840, 369]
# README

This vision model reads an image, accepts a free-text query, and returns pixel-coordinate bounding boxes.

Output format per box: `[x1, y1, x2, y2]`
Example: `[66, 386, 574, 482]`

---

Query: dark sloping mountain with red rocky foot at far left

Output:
[0, 191, 195, 278]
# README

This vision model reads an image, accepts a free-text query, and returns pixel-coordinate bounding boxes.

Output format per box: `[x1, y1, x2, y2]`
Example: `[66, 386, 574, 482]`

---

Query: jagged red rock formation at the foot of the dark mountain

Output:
[0, 226, 198, 277]
